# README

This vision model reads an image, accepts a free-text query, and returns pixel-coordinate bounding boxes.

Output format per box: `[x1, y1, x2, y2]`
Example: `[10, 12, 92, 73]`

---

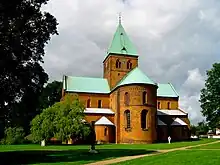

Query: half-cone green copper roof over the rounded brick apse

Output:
[115, 67, 157, 88]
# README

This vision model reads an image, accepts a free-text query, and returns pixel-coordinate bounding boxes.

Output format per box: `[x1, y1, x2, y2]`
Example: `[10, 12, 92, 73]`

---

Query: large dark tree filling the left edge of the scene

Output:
[0, 0, 58, 137]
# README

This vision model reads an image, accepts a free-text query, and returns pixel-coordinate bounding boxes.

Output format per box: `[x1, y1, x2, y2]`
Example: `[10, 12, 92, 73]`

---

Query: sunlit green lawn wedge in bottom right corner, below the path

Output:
[117, 150, 220, 165]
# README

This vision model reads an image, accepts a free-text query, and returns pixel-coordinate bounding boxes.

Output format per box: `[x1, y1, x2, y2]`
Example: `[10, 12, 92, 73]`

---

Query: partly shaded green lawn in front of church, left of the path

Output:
[0, 139, 217, 165]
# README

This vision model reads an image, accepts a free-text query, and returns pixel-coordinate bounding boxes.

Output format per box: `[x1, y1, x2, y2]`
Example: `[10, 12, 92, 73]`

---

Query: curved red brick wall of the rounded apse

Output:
[110, 85, 157, 143]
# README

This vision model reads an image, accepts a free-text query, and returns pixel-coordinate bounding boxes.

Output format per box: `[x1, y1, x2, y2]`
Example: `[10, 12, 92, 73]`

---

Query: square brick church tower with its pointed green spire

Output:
[103, 16, 138, 89]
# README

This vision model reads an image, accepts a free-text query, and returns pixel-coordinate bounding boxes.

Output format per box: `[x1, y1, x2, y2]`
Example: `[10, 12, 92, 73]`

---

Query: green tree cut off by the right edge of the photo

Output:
[200, 63, 220, 129]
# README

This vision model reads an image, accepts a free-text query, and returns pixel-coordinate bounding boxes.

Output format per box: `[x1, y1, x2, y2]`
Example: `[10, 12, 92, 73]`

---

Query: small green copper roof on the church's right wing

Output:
[157, 83, 179, 97]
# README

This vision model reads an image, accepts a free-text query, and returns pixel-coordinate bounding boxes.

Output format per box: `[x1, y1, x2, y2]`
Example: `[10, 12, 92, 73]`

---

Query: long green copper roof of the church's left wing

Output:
[63, 76, 110, 94]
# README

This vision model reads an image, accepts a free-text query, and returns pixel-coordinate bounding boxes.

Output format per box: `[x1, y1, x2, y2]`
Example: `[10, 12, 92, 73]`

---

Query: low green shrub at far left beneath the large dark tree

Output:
[1, 127, 25, 144]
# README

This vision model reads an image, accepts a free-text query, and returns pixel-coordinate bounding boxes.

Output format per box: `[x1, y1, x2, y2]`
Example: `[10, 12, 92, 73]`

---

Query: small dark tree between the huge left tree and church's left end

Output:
[39, 81, 62, 111]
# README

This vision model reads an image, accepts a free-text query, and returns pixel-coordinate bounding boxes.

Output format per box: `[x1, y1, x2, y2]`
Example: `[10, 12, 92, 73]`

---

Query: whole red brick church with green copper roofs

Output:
[63, 18, 190, 143]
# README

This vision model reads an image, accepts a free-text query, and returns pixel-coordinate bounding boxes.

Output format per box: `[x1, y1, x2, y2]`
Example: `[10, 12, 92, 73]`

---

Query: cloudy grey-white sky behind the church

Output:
[44, 0, 220, 123]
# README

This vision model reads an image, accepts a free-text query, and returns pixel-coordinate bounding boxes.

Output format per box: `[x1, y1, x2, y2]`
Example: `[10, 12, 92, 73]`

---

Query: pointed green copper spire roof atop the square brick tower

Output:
[107, 22, 138, 56]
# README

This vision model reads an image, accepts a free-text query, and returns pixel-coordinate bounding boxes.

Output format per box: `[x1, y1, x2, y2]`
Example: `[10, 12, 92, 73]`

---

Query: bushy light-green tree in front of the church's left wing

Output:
[31, 95, 91, 142]
